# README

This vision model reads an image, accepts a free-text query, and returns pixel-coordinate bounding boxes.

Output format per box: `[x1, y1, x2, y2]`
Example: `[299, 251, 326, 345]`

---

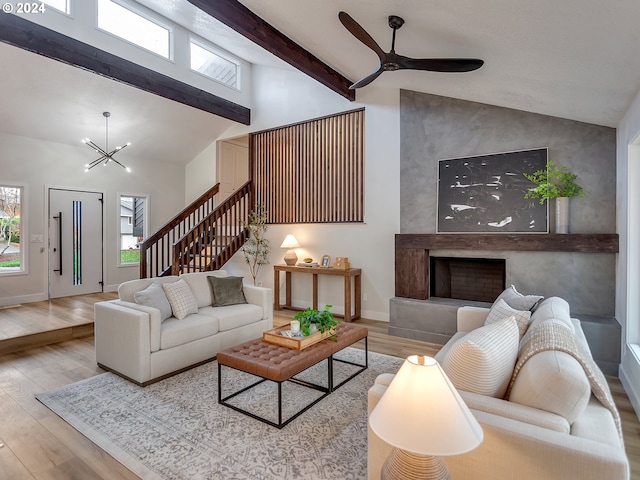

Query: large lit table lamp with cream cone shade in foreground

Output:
[369, 355, 483, 480]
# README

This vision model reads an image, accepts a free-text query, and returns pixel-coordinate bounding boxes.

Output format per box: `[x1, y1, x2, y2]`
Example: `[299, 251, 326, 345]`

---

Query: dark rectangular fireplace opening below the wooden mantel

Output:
[429, 257, 506, 302]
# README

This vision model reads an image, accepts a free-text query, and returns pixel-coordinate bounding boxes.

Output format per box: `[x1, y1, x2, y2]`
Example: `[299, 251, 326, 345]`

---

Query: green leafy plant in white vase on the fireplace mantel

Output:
[523, 160, 585, 233]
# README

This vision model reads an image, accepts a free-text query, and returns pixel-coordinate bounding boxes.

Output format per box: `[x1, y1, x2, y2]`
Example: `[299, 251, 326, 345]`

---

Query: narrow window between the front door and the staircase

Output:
[118, 194, 149, 265]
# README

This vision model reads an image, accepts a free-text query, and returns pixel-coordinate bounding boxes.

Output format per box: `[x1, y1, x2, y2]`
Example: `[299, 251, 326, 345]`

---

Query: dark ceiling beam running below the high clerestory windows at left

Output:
[0, 14, 251, 125]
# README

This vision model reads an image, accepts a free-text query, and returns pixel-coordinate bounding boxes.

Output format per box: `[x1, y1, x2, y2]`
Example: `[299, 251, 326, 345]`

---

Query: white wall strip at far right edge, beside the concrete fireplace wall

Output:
[616, 87, 640, 419]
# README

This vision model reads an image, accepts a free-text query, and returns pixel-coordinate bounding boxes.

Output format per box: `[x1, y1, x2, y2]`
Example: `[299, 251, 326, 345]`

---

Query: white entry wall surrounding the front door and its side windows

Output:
[0, 133, 185, 306]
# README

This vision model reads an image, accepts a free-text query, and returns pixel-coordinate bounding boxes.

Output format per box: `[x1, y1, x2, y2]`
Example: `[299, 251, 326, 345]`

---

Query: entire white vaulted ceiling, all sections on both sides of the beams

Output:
[0, 0, 640, 163]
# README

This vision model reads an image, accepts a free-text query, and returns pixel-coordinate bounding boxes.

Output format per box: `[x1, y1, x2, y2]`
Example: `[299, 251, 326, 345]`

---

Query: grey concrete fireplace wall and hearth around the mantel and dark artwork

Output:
[389, 90, 621, 375]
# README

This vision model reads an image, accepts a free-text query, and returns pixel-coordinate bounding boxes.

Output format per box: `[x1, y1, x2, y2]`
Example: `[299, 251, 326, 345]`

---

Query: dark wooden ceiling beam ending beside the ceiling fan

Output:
[188, 0, 356, 101]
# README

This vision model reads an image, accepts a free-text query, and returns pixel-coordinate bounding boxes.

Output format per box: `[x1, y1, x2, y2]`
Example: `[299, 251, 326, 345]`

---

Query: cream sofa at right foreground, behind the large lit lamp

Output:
[368, 297, 629, 480]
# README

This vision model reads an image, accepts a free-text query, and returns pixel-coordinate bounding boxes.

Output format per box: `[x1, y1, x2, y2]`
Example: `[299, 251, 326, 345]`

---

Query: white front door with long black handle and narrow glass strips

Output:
[49, 188, 103, 298]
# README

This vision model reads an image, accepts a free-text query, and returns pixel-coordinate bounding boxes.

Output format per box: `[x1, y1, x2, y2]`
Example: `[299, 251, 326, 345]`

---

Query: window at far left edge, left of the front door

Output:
[0, 184, 27, 275]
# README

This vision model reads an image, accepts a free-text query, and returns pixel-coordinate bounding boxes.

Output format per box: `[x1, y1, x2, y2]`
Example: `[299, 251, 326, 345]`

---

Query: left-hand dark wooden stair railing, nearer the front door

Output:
[140, 183, 220, 278]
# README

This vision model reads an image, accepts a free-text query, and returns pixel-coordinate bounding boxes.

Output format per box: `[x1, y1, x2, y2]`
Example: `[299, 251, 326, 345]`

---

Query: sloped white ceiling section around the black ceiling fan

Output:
[240, 0, 640, 126]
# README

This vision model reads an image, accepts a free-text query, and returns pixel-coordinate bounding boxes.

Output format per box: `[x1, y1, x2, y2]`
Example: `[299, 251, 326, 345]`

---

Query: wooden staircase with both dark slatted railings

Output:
[140, 181, 254, 278]
